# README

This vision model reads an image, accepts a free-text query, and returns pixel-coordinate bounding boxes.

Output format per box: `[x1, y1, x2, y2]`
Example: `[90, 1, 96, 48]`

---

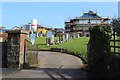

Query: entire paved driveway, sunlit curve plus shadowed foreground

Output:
[3, 51, 103, 79]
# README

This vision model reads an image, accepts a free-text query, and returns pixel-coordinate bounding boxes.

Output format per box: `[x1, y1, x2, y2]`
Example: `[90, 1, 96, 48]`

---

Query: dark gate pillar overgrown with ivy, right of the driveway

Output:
[89, 25, 113, 73]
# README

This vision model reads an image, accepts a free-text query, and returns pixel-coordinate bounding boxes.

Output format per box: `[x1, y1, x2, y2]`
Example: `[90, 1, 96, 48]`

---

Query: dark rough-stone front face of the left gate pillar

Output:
[7, 34, 20, 68]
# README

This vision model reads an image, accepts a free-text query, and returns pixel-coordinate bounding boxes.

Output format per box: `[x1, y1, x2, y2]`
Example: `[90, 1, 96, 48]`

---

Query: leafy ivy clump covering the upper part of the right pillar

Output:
[89, 25, 112, 52]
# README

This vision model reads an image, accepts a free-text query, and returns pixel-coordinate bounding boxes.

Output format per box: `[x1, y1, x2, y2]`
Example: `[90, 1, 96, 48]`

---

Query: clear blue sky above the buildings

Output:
[2, 2, 118, 29]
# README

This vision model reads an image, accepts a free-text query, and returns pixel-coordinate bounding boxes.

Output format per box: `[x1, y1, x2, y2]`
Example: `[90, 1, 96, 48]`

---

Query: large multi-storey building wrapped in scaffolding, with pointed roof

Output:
[65, 10, 110, 38]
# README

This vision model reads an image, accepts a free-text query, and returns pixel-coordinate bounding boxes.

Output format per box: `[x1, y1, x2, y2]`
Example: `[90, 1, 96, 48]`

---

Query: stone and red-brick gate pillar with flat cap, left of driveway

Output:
[7, 30, 28, 68]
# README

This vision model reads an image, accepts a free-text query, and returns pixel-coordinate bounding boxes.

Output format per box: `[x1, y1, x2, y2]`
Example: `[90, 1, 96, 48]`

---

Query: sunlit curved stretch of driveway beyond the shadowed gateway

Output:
[39, 52, 83, 69]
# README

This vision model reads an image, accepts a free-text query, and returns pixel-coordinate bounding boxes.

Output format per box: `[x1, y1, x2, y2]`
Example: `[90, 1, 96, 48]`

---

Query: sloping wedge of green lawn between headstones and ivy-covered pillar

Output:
[51, 37, 89, 58]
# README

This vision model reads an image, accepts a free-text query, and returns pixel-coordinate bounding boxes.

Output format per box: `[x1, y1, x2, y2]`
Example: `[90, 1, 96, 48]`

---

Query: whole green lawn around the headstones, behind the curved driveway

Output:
[28, 37, 89, 58]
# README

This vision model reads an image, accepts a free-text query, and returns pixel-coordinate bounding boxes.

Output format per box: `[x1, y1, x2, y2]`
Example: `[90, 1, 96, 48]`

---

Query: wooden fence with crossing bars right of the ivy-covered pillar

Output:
[110, 31, 120, 54]
